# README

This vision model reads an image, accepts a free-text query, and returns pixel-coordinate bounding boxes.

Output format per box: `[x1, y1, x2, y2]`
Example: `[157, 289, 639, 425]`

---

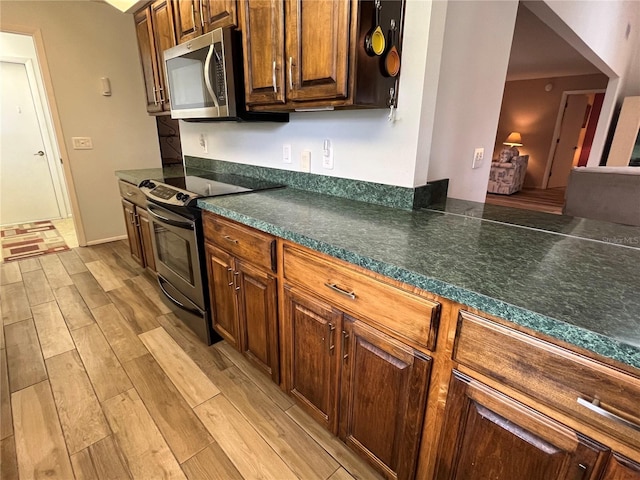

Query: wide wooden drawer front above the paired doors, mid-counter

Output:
[284, 245, 440, 350]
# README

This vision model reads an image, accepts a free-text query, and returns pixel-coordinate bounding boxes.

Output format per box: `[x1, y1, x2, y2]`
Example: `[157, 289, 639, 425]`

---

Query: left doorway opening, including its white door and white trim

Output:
[0, 32, 79, 248]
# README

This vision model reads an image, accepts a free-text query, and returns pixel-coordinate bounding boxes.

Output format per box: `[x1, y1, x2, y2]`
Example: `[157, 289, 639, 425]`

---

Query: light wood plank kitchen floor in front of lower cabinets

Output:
[0, 242, 379, 480]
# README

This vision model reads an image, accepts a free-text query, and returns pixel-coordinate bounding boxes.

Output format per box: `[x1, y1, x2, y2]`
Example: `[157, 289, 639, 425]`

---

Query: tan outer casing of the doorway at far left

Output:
[0, 25, 87, 247]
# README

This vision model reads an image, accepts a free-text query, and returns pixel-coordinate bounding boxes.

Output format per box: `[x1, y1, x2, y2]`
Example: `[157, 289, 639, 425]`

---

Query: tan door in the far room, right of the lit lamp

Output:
[547, 94, 589, 188]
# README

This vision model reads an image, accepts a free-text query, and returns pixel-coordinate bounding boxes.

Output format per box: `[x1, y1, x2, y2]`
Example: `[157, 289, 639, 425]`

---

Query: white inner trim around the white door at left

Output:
[0, 56, 70, 218]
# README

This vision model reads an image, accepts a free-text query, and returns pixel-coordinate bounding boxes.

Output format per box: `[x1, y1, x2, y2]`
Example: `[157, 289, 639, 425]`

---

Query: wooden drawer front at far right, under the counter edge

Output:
[453, 311, 640, 448]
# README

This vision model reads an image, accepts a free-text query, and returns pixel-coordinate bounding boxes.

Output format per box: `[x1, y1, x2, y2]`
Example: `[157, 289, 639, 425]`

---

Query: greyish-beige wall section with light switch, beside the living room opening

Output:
[428, 0, 518, 202]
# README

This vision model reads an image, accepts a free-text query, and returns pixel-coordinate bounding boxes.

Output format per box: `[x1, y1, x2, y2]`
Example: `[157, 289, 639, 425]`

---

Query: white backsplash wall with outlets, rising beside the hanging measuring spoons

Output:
[180, 0, 438, 191]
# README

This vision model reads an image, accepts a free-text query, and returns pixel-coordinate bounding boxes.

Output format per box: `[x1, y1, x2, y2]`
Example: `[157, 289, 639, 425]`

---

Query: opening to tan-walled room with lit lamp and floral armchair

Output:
[485, 2, 610, 214]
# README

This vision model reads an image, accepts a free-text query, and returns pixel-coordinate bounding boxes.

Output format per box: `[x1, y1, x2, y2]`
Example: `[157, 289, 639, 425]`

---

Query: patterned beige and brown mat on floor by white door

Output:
[0, 220, 69, 262]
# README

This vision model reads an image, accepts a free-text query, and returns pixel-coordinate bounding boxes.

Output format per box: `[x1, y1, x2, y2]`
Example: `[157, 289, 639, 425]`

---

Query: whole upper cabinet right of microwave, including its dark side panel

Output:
[239, 0, 404, 110]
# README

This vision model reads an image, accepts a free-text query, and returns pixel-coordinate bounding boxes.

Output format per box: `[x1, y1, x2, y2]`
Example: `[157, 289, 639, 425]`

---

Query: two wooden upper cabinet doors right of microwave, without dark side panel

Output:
[241, 0, 351, 109]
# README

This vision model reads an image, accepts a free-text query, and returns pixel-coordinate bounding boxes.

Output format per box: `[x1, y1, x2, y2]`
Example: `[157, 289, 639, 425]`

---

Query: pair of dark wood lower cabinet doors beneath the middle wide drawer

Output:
[285, 286, 431, 479]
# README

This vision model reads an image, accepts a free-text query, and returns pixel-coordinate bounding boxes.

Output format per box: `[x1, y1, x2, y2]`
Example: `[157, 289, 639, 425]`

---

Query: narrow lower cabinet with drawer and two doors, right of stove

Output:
[203, 212, 280, 383]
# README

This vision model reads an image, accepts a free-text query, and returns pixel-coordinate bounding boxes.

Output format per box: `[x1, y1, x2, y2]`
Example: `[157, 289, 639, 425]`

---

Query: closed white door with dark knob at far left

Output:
[0, 61, 64, 225]
